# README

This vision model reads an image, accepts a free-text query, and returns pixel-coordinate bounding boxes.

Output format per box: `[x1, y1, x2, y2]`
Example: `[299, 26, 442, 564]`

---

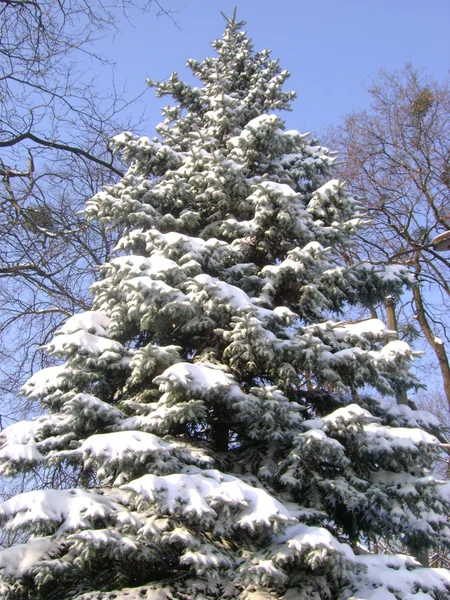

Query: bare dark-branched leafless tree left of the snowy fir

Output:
[0, 0, 179, 422]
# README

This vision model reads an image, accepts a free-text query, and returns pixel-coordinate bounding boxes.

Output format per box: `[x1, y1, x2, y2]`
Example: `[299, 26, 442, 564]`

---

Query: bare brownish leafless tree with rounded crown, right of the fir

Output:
[327, 65, 450, 406]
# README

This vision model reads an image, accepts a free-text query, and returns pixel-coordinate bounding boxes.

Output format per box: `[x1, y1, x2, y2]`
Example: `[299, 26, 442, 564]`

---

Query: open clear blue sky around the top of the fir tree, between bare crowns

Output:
[93, 0, 450, 135]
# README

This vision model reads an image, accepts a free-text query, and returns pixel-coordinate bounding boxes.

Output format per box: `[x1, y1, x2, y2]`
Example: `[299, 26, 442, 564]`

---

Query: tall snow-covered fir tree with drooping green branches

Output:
[0, 10, 450, 600]
